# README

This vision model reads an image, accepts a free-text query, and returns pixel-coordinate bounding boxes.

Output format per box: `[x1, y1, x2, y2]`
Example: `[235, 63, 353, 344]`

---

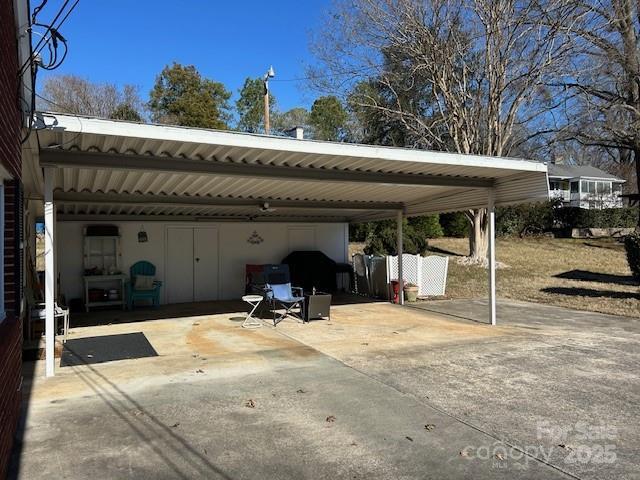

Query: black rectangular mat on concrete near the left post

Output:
[60, 332, 158, 367]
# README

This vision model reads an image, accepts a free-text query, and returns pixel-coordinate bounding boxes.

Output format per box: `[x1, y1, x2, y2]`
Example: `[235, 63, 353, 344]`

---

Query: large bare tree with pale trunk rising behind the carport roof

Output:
[311, 0, 574, 262]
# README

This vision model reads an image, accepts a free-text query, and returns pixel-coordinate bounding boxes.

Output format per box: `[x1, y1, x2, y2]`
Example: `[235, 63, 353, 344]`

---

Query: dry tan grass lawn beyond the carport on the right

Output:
[429, 238, 640, 317]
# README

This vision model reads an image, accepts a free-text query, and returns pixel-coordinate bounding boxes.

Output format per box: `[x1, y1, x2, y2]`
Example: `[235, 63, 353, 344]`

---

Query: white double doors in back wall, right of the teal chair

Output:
[165, 227, 218, 303]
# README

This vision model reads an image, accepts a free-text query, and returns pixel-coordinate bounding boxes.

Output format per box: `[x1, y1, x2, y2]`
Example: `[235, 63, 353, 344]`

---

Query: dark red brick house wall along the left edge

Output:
[0, 0, 22, 478]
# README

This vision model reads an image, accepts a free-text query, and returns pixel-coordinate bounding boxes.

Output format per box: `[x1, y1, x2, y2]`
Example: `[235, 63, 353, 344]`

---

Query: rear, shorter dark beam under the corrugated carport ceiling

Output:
[54, 192, 403, 211]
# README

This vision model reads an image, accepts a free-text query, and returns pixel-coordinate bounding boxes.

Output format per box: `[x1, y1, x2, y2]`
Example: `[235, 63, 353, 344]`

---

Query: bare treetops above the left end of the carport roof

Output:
[39, 75, 143, 118]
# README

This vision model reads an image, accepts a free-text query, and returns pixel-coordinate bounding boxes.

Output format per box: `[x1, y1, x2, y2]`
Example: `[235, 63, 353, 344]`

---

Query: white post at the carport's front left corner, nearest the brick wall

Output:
[44, 167, 56, 377]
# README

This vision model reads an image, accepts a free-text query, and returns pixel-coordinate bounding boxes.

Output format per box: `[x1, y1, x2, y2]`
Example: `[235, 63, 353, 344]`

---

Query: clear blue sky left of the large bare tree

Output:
[31, 0, 329, 110]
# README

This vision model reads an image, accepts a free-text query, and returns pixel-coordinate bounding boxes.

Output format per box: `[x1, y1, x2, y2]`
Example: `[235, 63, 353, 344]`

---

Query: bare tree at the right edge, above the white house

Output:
[560, 0, 640, 227]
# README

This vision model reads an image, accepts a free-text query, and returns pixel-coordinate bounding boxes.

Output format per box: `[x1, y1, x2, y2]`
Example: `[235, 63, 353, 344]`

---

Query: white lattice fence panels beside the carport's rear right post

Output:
[387, 253, 449, 296]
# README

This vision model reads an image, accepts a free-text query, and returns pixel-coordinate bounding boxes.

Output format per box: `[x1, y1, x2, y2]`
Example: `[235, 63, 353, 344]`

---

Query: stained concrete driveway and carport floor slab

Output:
[11, 302, 640, 479]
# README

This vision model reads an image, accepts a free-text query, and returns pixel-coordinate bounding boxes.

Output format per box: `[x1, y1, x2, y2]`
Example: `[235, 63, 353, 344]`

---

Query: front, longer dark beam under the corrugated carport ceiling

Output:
[40, 149, 493, 188]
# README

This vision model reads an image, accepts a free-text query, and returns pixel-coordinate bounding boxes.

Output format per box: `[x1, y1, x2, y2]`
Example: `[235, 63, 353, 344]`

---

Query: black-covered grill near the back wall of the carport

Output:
[282, 250, 337, 292]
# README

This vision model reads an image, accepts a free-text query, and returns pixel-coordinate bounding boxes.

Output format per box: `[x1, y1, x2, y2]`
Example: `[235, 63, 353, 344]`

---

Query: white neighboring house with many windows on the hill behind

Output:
[548, 164, 625, 209]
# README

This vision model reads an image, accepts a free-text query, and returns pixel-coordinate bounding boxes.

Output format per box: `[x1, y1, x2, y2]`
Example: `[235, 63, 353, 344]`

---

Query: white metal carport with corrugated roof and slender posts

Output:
[23, 113, 548, 375]
